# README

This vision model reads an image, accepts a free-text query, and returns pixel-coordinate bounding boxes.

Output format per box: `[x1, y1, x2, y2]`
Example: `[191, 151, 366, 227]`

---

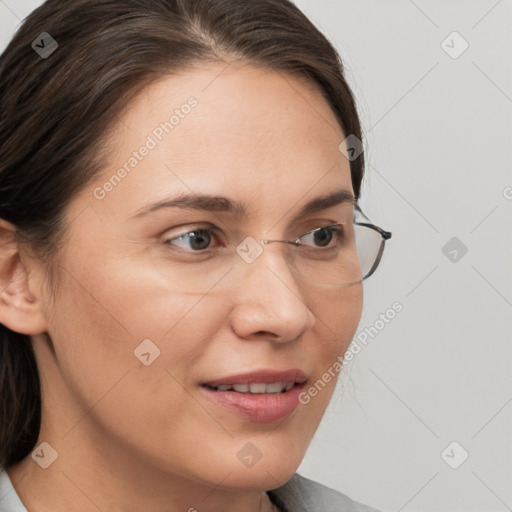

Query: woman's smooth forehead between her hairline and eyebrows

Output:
[87, 63, 352, 221]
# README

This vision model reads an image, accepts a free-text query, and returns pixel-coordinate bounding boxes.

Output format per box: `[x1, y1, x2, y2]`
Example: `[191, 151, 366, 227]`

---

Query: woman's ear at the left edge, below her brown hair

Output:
[0, 219, 47, 335]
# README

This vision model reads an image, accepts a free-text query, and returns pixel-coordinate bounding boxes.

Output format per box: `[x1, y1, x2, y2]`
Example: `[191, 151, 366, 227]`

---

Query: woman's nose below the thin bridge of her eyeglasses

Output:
[231, 243, 315, 342]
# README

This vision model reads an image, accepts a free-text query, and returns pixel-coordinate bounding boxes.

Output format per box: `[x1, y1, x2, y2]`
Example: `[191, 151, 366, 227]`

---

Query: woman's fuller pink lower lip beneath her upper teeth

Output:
[201, 384, 304, 423]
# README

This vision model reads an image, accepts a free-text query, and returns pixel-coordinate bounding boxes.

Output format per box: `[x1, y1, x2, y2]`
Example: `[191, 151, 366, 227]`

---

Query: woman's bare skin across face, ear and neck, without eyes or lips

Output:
[0, 63, 363, 512]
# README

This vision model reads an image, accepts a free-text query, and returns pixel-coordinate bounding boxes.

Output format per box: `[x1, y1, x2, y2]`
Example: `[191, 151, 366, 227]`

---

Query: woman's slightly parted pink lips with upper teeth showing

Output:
[201, 369, 307, 422]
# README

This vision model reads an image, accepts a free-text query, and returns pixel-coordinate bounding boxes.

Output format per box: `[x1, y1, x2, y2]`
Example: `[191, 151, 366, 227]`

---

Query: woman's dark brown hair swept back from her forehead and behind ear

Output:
[0, 0, 364, 468]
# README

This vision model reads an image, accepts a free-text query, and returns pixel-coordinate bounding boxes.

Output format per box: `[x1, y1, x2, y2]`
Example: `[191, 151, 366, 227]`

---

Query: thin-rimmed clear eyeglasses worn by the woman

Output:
[148, 205, 391, 294]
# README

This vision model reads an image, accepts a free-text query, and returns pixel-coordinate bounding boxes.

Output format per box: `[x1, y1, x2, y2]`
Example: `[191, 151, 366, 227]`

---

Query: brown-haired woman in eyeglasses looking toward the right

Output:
[0, 0, 391, 512]
